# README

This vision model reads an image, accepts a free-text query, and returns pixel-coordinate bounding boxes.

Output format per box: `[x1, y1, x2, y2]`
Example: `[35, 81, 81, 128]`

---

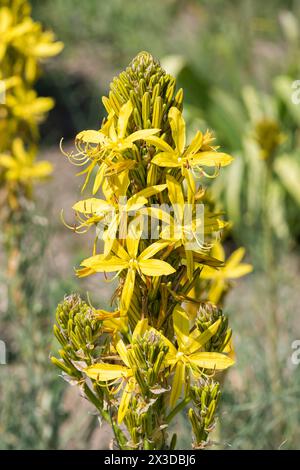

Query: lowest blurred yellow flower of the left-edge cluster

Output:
[0, 138, 52, 183]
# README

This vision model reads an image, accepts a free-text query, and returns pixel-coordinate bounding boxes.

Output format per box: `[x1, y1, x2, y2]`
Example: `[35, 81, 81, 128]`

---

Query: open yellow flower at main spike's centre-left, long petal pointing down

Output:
[78, 232, 175, 315]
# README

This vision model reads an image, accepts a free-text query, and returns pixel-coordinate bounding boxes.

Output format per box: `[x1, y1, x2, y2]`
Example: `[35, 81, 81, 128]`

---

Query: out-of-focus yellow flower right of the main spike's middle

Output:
[201, 243, 253, 304]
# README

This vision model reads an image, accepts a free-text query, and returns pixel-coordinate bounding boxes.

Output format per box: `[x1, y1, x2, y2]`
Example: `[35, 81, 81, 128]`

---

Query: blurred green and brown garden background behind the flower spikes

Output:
[0, 0, 300, 449]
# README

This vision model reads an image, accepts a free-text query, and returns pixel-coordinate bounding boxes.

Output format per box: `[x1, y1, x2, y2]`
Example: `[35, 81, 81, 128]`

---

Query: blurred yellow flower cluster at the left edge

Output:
[0, 0, 63, 208]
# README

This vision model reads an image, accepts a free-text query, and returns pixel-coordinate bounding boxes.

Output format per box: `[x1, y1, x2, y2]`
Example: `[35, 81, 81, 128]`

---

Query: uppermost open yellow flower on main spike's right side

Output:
[147, 107, 233, 193]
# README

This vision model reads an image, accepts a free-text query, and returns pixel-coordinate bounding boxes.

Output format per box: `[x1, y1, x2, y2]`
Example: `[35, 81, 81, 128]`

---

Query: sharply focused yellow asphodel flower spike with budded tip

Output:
[53, 52, 248, 450]
